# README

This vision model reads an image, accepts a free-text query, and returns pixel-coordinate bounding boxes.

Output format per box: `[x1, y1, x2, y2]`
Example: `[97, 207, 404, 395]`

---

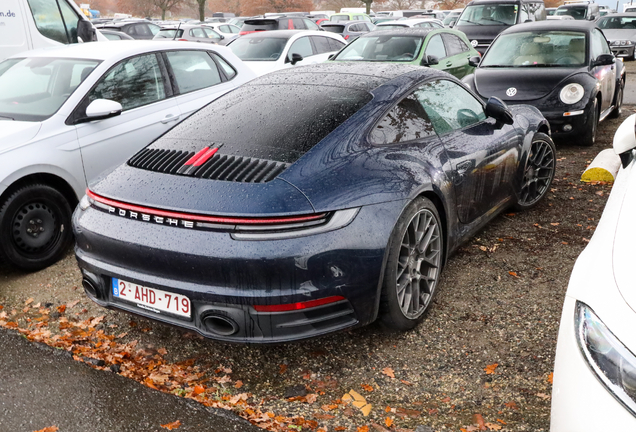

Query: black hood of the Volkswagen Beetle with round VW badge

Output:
[475, 67, 583, 102]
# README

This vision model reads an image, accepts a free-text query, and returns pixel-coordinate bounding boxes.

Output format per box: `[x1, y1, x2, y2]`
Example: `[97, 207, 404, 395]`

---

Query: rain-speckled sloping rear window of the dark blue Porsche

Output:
[152, 85, 372, 163]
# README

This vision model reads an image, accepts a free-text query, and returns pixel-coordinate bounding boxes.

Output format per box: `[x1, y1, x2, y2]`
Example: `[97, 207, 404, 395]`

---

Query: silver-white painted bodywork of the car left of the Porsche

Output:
[0, 41, 256, 199]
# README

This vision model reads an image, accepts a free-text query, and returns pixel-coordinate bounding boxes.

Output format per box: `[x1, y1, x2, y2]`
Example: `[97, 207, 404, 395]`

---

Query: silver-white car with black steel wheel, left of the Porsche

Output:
[0, 41, 255, 270]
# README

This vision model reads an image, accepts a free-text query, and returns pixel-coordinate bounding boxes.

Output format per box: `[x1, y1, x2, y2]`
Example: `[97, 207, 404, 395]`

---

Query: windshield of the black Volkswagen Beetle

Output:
[479, 31, 587, 68]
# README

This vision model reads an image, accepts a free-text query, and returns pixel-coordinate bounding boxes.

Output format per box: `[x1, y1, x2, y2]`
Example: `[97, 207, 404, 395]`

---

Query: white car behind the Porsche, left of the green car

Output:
[228, 30, 346, 76]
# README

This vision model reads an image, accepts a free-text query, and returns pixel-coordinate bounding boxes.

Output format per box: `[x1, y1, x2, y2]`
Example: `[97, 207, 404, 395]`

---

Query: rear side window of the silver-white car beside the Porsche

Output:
[166, 51, 221, 94]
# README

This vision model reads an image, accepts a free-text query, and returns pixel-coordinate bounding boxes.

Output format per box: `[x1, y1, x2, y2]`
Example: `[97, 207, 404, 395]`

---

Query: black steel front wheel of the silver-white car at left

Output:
[0, 184, 73, 271]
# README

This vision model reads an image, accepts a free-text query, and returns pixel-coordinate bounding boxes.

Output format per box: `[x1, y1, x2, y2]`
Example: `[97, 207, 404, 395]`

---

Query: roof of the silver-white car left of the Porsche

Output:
[12, 40, 230, 61]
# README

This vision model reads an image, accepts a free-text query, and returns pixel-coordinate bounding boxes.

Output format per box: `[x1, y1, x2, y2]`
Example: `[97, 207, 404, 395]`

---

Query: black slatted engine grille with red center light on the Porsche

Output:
[128, 148, 290, 183]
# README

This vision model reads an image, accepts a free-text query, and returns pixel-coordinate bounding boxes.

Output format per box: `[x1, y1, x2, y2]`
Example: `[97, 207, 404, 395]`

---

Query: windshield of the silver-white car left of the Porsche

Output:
[0, 57, 99, 121]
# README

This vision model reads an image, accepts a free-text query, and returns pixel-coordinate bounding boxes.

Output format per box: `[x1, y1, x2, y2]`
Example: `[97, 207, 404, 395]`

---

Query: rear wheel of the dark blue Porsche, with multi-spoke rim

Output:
[380, 198, 444, 331]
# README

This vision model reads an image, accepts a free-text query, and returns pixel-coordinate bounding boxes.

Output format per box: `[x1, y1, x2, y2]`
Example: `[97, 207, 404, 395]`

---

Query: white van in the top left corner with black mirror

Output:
[0, 0, 107, 61]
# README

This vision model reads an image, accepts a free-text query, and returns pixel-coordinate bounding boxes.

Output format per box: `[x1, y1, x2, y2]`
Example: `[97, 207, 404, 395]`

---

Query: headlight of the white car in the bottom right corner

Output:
[575, 302, 636, 415]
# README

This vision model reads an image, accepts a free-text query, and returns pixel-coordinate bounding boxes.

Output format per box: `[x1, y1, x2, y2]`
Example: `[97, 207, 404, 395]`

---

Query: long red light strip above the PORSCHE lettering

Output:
[86, 189, 327, 225]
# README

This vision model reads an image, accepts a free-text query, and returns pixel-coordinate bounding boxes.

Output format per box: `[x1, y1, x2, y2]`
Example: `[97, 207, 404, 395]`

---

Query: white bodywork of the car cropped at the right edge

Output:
[550, 118, 636, 432]
